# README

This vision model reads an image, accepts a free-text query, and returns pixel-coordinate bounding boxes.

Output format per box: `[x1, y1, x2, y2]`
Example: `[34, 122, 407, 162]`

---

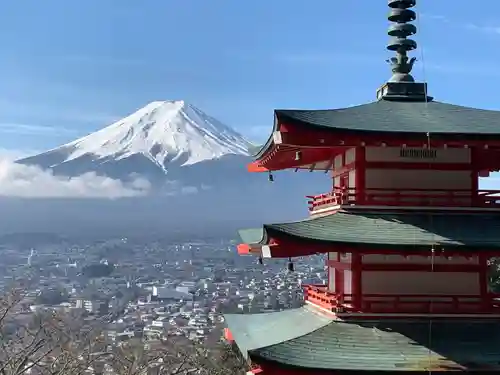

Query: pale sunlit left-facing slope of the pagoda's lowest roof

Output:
[224, 306, 331, 357]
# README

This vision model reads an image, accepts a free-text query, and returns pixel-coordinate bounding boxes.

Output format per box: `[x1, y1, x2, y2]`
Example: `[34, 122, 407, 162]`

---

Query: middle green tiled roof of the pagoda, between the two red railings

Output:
[240, 210, 500, 250]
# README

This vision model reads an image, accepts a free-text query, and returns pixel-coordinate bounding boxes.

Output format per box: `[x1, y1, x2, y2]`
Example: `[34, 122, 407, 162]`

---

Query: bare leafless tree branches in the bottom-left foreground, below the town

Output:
[0, 290, 246, 375]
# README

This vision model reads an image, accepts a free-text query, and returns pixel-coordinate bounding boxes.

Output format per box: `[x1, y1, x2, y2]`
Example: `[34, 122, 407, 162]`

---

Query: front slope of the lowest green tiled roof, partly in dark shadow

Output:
[254, 316, 500, 371]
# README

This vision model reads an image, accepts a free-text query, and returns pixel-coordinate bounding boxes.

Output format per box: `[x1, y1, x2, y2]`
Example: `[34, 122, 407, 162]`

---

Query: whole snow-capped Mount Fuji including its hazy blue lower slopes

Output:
[9, 101, 331, 234]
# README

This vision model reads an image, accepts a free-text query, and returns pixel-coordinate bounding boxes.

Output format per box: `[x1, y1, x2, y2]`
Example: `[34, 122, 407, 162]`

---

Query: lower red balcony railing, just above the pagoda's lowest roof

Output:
[304, 285, 500, 314]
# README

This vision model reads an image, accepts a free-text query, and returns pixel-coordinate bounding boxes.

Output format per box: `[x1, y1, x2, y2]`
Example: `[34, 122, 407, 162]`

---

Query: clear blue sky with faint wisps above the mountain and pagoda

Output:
[0, 0, 500, 154]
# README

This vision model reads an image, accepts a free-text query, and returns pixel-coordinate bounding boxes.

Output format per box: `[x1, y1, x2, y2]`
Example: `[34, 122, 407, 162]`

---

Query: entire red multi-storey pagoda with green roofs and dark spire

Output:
[225, 0, 500, 375]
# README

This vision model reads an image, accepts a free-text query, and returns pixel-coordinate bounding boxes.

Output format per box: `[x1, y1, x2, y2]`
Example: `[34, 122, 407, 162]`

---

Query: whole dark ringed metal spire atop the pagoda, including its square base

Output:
[377, 0, 432, 102]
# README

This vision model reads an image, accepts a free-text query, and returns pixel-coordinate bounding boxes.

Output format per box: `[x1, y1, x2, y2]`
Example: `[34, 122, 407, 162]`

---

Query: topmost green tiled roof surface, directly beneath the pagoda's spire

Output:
[275, 100, 500, 136]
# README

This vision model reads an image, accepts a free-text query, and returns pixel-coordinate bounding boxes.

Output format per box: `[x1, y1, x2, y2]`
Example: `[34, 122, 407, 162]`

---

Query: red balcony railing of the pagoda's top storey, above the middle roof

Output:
[307, 188, 500, 212]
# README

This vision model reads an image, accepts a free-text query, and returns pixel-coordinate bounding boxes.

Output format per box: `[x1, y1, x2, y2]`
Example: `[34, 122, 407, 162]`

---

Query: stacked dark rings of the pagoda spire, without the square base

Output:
[387, 0, 417, 82]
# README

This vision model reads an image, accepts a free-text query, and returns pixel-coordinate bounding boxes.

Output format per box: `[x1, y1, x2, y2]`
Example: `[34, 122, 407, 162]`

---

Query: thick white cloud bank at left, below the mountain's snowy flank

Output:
[0, 154, 151, 199]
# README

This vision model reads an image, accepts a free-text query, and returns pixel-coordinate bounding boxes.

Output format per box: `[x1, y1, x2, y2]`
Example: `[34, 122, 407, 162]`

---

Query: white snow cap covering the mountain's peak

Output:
[59, 100, 251, 169]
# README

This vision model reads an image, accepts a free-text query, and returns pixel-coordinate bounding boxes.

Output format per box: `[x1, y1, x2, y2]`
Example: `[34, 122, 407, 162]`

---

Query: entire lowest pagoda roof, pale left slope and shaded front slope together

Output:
[225, 306, 500, 371]
